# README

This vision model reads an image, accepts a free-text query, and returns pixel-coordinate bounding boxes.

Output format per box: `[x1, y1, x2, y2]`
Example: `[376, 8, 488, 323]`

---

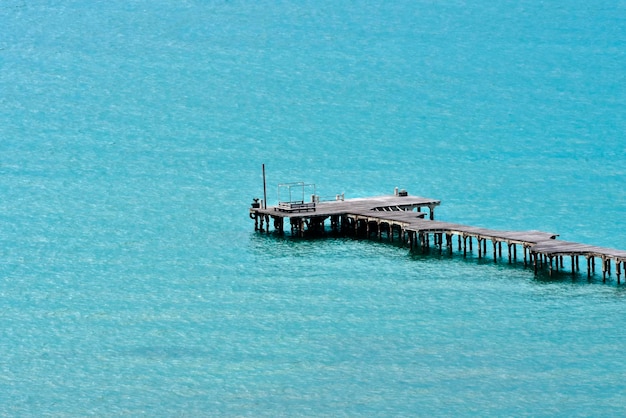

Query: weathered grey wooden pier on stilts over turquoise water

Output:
[250, 189, 626, 284]
